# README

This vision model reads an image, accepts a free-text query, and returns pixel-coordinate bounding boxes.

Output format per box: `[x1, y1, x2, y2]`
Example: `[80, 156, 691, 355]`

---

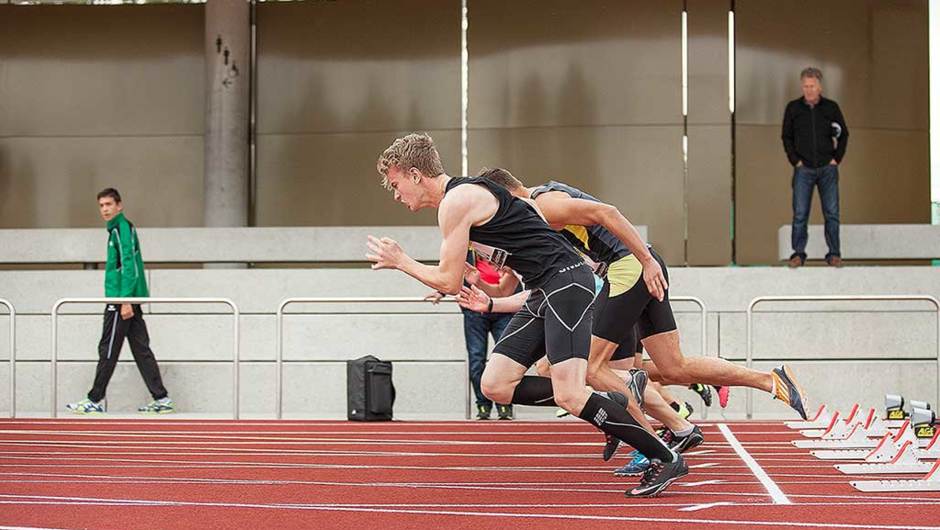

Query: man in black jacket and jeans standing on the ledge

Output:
[782, 67, 849, 267]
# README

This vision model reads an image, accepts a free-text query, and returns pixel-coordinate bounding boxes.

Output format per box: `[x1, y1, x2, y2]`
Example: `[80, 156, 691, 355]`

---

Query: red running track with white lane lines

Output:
[0, 418, 940, 530]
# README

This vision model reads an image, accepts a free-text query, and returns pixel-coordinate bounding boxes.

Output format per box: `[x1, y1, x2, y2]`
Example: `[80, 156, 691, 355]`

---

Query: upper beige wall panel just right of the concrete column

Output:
[258, 0, 460, 134]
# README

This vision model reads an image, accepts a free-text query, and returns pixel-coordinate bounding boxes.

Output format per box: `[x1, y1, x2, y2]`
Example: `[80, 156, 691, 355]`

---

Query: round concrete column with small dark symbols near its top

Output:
[205, 0, 251, 226]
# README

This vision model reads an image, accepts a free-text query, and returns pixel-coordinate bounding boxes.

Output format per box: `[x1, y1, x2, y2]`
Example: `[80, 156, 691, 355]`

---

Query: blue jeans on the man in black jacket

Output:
[791, 164, 842, 260]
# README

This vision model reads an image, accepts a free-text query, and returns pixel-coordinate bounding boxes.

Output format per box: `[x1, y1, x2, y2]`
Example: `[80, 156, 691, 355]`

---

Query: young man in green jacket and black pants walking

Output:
[67, 188, 174, 414]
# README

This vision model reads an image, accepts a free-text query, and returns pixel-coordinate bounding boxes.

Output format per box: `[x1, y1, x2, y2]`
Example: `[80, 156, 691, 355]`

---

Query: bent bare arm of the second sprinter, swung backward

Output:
[535, 191, 669, 301]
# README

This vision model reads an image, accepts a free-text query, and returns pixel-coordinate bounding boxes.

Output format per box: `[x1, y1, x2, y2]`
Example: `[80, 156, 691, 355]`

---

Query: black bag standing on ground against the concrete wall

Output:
[346, 355, 395, 421]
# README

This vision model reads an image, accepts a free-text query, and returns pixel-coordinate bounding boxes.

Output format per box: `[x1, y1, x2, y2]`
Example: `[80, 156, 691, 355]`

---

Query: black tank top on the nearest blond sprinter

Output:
[444, 177, 584, 289]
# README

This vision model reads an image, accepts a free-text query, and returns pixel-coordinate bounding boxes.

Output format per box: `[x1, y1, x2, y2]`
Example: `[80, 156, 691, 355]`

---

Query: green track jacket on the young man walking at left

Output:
[104, 212, 150, 298]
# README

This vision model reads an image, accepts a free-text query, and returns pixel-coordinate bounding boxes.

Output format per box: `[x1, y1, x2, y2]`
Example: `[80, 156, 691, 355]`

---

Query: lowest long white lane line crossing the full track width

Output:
[0, 495, 940, 530]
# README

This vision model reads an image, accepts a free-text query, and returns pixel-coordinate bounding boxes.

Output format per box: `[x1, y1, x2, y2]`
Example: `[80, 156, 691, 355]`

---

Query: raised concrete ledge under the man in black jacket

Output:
[777, 224, 940, 260]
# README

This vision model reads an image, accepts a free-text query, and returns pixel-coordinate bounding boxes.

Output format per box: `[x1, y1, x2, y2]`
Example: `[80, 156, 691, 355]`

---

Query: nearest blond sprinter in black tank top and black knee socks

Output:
[366, 134, 688, 497]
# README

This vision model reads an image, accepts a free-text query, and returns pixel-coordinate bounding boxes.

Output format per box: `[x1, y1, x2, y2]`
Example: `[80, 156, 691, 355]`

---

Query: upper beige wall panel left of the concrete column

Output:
[0, 5, 205, 136]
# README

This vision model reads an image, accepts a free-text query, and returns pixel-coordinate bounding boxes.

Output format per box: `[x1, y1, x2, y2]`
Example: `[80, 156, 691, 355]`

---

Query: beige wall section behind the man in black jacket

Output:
[735, 0, 930, 264]
